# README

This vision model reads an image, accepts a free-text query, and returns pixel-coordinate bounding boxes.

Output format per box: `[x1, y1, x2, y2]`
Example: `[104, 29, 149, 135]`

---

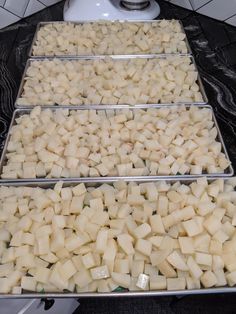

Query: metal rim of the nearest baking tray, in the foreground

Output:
[0, 178, 236, 299]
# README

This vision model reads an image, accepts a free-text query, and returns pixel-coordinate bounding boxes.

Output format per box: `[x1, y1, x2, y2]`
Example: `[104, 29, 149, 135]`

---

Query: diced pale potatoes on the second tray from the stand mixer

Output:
[17, 56, 203, 105]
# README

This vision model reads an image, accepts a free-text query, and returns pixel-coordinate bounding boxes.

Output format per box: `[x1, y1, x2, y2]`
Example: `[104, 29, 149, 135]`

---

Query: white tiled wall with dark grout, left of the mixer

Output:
[0, 0, 61, 29]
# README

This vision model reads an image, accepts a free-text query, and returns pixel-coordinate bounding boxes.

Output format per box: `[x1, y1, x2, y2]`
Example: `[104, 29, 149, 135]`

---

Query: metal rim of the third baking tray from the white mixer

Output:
[0, 104, 234, 183]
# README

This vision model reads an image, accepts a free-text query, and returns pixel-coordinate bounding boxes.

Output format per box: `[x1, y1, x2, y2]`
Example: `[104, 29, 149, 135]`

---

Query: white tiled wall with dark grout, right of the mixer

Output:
[166, 0, 236, 26]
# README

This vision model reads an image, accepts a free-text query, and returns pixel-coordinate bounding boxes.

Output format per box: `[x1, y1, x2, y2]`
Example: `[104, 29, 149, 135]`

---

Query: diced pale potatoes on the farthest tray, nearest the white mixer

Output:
[32, 20, 188, 56]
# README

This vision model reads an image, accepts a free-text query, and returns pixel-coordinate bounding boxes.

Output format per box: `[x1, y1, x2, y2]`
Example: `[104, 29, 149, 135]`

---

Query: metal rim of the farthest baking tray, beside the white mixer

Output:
[28, 20, 192, 58]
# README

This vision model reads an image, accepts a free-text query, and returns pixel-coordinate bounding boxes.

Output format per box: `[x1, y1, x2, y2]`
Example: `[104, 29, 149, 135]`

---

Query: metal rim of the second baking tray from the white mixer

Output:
[15, 54, 208, 108]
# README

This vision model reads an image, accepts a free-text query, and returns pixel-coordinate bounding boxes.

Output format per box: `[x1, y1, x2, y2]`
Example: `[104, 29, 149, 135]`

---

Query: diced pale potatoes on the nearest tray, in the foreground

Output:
[0, 177, 236, 293]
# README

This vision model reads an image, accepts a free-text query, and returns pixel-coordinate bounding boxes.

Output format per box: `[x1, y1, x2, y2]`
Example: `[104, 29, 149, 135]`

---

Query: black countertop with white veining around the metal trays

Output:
[0, 0, 236, 314]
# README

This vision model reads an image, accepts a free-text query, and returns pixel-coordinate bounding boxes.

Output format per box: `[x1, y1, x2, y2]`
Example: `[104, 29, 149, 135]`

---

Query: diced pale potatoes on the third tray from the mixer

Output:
[1, 105, 230, 179]
